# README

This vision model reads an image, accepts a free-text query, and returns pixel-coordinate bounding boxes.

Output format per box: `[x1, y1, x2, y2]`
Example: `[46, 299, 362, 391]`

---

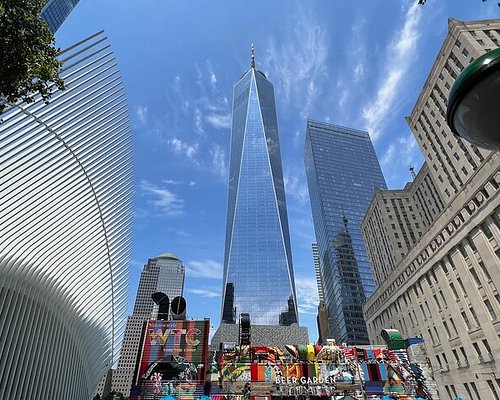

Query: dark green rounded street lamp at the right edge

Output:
[446, 48, 500, 150]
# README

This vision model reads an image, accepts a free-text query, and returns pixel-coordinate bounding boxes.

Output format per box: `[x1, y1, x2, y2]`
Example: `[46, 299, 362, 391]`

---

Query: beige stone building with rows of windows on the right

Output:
[362, 19, 500, 400]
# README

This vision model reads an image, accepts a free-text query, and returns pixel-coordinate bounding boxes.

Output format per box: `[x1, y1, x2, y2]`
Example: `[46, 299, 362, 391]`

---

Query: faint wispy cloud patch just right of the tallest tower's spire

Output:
[263, 5, 328, 117]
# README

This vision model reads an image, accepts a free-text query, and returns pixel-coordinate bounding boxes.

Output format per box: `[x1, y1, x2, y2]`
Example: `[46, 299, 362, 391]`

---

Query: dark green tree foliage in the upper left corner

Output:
[0, 0, 64, 114]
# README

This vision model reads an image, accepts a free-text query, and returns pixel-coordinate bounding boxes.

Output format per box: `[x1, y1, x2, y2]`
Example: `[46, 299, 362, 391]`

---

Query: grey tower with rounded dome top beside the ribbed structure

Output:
[109, 253, 185, 396]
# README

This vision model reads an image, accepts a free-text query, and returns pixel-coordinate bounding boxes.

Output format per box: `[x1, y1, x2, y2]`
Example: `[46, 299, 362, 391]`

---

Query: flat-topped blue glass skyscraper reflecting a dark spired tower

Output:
[304, 120, 387, 344]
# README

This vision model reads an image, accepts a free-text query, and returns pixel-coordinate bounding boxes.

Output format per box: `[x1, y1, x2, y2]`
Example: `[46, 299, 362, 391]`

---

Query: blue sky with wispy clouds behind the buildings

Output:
[52, 0, 500, 342]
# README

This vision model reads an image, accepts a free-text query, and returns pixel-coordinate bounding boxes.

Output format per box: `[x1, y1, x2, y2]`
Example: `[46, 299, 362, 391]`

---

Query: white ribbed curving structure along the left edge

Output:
[0, 32, 132, 399]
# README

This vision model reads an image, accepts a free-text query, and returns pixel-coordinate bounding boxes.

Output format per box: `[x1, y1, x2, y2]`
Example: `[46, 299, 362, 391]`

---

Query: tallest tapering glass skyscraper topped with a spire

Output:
[222, 52, 298, 325]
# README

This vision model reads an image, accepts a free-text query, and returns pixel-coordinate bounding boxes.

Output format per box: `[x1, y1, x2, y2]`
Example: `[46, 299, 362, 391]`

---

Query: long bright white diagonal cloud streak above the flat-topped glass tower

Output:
[363, 1, 422, 140]
